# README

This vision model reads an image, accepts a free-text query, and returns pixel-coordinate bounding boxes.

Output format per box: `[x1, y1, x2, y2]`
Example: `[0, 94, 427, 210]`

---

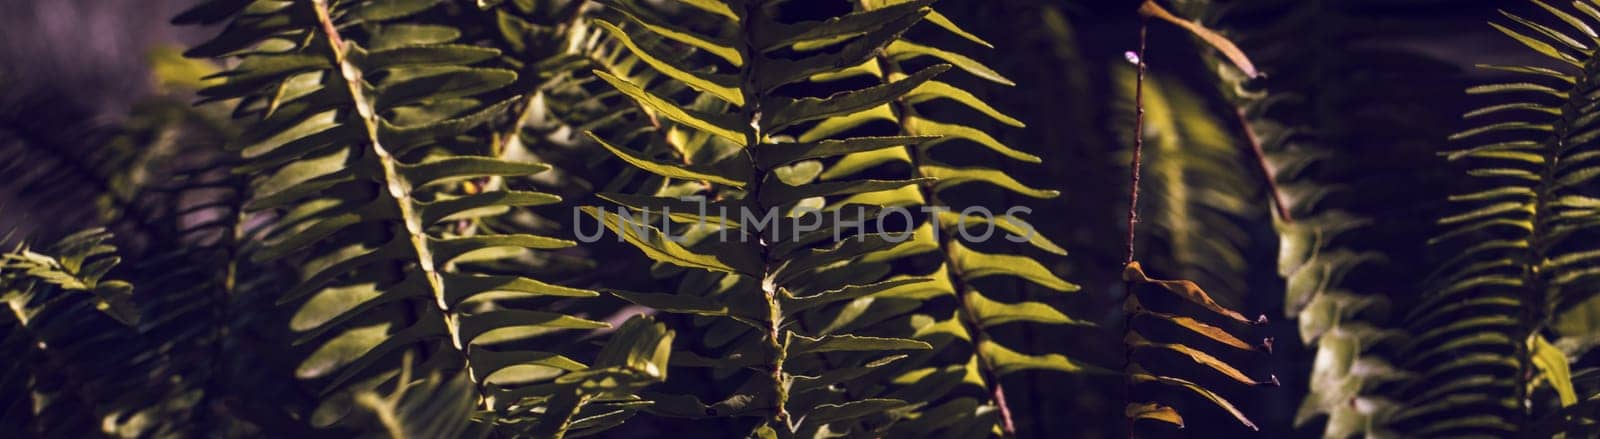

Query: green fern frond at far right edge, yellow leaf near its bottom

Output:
[1392, 2, 1600, 434]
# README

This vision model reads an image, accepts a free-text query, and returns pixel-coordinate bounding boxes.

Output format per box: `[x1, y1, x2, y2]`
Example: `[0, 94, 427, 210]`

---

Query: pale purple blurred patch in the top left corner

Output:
[0, 0, 208, 120]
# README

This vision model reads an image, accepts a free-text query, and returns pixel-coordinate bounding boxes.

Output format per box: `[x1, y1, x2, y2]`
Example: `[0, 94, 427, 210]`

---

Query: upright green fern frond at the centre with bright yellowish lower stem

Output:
[589, 2, 972, 437]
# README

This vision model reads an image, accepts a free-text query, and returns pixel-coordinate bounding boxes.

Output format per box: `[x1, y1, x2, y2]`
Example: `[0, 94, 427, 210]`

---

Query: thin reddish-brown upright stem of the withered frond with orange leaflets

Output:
[1122, 14, 1149, 437]
